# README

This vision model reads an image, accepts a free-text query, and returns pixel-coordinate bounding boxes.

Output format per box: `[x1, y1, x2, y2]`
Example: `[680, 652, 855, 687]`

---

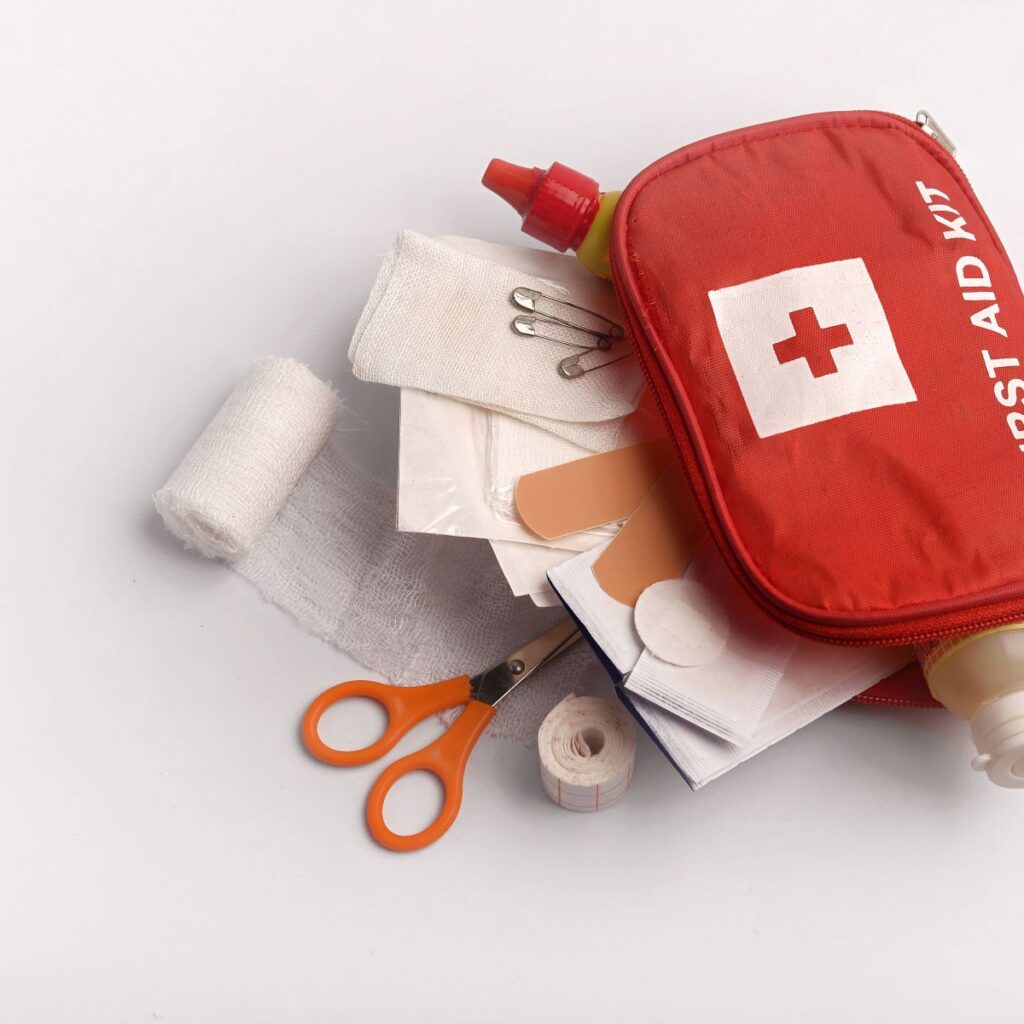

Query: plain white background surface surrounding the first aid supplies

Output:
[0, 0, 1024, 1024]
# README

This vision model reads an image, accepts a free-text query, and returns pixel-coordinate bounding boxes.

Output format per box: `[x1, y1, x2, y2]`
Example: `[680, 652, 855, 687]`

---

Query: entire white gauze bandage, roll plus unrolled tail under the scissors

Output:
[157, 359, 599, 740]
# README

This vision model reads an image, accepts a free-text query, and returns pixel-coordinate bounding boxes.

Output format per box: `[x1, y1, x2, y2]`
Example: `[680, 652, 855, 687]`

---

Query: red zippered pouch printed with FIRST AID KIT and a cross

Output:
[611, 113, 1024, 644]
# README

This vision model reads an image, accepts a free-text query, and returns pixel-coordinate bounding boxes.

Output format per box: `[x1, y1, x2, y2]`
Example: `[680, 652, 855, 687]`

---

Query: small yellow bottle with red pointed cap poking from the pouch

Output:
[483, 159, 622, 279]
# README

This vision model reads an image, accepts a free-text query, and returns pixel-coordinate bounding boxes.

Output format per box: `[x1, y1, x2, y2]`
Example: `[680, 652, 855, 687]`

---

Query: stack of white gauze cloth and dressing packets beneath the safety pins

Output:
[349, 231, 659, 605]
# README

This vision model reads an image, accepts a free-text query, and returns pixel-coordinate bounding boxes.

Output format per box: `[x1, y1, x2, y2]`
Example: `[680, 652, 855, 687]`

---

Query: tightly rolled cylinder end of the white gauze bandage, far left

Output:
[154, 358, 338, 559]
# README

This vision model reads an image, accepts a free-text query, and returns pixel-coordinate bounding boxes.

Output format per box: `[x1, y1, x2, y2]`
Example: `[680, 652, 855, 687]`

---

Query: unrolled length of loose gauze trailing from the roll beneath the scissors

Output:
[234, 445, 599, 741]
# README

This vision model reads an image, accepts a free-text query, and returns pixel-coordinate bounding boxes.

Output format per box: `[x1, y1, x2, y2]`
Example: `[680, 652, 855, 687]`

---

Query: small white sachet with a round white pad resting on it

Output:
[625, 544, 797, 742]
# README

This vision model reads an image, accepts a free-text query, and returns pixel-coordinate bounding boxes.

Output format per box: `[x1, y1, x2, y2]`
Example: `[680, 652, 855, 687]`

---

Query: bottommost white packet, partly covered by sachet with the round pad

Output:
[627, 638, 912, 790]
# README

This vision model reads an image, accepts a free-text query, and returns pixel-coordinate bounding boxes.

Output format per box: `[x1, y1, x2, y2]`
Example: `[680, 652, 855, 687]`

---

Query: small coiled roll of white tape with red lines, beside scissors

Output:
[537, 695, 637, 811]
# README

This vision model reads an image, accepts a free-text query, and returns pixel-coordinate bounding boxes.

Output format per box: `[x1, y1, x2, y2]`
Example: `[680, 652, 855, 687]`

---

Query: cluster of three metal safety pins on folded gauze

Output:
[511, 288, 632, 380]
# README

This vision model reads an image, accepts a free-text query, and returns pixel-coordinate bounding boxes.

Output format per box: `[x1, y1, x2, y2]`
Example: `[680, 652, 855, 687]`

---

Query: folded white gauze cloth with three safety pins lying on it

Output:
[348, 231, 643, 446]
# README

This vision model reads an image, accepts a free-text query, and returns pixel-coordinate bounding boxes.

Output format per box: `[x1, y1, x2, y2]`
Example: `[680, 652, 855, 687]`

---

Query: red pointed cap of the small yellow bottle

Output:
[483, 159, 600, 252]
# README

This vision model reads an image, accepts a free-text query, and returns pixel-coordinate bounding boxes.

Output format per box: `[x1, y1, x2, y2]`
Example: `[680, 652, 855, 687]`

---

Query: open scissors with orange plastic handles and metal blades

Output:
[302, 618, 581, 851]
